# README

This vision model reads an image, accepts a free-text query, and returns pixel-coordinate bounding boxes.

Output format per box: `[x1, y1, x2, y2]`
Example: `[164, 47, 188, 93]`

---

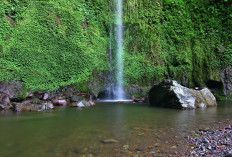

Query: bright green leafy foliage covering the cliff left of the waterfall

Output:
[0, 0, 109, 90]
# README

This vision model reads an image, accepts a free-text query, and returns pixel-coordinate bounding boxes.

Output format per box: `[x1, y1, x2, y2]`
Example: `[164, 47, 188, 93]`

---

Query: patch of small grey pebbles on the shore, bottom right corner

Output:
[188, 124, 232, 157]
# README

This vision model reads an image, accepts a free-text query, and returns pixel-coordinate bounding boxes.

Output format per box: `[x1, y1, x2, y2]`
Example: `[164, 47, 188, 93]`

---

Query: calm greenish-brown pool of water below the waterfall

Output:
[0, 102, 232, 157]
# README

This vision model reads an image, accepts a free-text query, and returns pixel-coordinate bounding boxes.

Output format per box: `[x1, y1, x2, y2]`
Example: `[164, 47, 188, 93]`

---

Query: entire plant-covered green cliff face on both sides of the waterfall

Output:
[0, 0, 232, 96]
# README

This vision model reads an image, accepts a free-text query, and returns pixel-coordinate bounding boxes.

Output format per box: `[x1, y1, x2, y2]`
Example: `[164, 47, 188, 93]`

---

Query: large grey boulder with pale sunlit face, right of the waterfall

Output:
[149, 80, 217, 109]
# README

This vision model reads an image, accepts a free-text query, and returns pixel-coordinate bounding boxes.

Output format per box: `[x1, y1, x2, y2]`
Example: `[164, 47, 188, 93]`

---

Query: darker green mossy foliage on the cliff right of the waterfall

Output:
[125, 0, 232, 86]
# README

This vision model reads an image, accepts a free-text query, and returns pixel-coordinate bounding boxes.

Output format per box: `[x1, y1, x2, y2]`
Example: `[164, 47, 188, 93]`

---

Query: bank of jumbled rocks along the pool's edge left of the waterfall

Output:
[0, 81, 95, 112]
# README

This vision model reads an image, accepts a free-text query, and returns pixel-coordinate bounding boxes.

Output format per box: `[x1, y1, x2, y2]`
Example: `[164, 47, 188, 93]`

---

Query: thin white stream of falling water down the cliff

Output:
[115, 0, 125, 100]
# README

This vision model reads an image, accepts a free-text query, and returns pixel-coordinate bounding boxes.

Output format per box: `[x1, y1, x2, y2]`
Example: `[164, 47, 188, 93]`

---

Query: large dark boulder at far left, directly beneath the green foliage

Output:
[0, 81, 26, 100]
